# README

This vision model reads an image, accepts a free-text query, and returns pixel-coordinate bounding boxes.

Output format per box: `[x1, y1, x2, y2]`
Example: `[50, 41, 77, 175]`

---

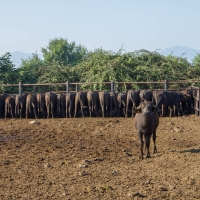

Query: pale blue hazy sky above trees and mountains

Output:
[0, 0, 200, 55]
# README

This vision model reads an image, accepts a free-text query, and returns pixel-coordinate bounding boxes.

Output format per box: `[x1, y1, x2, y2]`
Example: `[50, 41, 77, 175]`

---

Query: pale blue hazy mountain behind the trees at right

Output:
[159, 46, 200, 63]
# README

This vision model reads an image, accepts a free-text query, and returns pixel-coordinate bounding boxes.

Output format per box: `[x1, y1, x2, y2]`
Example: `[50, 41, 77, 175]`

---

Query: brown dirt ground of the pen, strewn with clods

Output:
[0, 115, 200, 200]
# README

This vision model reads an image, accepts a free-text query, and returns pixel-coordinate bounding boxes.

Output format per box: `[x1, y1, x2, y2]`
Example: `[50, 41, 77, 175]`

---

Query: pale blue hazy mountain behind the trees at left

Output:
[10, 51, 43, 68]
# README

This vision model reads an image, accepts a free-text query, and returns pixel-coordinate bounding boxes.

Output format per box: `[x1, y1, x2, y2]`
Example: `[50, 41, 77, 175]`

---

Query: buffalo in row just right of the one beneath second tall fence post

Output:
[74, 91, 88, 117]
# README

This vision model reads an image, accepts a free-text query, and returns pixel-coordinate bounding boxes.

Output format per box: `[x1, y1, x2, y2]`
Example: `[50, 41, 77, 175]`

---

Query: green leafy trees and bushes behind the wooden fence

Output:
[0, 38, 200, 92]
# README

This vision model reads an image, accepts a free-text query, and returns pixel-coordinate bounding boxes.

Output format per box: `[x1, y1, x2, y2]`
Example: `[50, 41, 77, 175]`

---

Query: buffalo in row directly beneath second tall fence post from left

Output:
[66, 92, 76, 117]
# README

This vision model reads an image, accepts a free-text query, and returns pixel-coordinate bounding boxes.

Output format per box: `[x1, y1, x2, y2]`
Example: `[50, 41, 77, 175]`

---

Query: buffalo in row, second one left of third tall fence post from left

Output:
[87, 91, 99, 117]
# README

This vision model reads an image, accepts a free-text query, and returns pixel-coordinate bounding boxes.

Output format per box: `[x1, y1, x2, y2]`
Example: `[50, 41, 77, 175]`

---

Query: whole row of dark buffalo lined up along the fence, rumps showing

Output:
[0, 89, 194, 118]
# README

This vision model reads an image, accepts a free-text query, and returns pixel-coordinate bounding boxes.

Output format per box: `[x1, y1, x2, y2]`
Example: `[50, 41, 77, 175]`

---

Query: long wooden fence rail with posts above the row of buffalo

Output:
[0, 80, 200, 94]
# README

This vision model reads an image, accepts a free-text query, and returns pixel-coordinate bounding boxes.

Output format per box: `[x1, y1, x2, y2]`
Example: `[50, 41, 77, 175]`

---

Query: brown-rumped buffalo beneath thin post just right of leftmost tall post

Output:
[26, 94, 38, 119]
